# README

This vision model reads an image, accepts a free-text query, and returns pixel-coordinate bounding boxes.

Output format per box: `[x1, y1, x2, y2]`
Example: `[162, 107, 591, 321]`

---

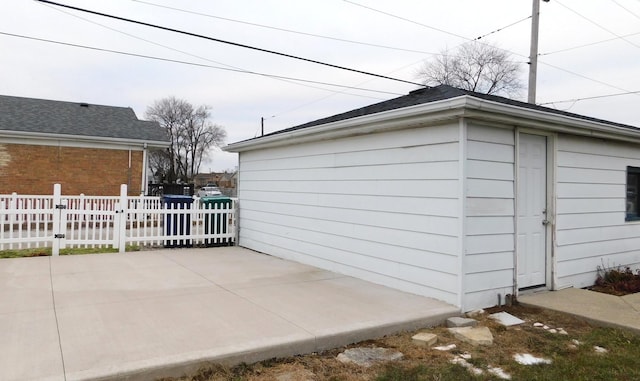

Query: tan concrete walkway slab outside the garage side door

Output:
[518, 288, 640, 333]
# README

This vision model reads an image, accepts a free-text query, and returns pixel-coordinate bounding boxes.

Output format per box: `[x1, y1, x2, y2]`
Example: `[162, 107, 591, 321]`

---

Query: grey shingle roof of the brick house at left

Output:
[0, 95, 169, 142]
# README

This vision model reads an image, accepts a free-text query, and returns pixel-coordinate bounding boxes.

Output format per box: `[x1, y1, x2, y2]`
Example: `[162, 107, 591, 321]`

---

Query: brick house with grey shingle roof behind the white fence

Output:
[0, 96, 169, 196]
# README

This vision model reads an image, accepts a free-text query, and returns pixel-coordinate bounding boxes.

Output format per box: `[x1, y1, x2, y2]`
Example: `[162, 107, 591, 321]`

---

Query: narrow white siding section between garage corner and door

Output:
[463, 124, 515, 311]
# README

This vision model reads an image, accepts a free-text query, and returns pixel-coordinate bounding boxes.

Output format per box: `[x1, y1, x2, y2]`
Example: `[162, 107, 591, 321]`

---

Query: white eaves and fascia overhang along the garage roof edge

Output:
[223, 95, 640, 152]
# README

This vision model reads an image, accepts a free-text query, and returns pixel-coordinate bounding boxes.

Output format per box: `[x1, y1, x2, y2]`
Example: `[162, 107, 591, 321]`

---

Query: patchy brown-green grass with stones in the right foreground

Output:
[154, 306, 640, 381]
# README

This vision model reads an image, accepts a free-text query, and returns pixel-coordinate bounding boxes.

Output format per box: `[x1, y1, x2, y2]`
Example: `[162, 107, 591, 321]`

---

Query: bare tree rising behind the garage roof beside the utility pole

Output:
[417, 42, 524, 97]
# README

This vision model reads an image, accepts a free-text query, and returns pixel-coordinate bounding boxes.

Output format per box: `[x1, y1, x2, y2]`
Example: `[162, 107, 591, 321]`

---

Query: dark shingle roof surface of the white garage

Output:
[258, 85, 638, 140]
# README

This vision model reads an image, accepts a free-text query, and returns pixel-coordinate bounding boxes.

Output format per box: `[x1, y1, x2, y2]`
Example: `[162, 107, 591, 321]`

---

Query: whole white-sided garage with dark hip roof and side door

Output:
[225, 86, 640, 311]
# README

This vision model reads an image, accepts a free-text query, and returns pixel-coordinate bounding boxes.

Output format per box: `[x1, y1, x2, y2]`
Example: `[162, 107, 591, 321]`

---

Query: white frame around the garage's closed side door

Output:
[513, 127, 558, 295]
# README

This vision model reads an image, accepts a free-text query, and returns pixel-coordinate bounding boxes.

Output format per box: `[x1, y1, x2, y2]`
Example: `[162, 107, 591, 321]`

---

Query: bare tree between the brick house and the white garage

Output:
[145, 97, 227, 182]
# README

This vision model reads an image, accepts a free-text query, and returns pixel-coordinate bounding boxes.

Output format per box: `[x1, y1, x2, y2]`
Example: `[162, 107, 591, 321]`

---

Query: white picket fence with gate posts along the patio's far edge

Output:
[0, 184, 237, 255]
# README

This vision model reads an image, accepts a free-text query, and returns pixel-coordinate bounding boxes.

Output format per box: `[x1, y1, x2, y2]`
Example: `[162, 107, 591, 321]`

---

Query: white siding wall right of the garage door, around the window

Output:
[555, 135, 640, 288]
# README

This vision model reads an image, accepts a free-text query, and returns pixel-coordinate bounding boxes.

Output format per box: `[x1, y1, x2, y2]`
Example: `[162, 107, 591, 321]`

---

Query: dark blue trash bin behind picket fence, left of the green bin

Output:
[162, 194, 193, 247]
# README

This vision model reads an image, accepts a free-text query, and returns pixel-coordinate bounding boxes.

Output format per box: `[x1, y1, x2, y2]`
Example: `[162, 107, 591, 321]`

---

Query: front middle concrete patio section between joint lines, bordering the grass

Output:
[58, 291, 314, 380]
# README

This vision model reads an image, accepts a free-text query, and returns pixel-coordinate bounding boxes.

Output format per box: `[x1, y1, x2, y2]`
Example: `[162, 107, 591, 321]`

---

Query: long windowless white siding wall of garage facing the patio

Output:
[239, 124, 460, 305]
